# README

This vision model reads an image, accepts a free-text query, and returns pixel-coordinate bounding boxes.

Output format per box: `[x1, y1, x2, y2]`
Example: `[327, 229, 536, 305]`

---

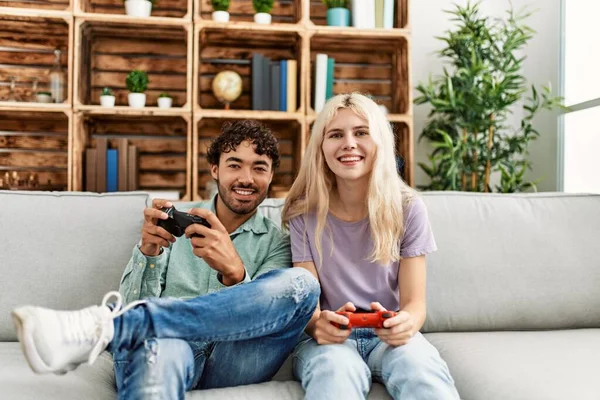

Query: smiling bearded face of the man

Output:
[211, 140, 273, 215]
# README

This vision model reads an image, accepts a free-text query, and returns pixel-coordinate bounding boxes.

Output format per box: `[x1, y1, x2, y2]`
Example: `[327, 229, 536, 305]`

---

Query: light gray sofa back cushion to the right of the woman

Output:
[423, 192, 600, 332]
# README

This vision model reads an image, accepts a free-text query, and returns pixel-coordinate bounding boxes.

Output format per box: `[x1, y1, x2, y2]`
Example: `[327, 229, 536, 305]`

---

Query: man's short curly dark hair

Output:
[207, 120, 279, 170]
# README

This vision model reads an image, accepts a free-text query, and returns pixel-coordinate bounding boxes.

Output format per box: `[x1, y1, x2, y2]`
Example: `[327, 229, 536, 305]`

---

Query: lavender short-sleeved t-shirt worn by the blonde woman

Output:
[290, 197, 437, 310]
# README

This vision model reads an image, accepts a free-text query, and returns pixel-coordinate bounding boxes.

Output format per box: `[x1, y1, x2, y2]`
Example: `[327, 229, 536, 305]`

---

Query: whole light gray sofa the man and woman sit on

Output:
[0, 191, 600, 400]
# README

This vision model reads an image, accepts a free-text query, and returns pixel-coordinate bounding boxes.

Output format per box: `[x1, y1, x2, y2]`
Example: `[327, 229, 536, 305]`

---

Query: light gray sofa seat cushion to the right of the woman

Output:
[425, 329, 600, 400]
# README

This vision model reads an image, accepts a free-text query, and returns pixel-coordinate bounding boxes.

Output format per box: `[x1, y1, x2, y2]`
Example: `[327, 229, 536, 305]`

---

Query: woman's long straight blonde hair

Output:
[282, 93, 415, 265]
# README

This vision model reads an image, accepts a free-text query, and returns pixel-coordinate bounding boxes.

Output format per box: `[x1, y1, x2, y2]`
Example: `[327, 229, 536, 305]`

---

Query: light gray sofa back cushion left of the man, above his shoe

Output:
[0, 191, 148, 341]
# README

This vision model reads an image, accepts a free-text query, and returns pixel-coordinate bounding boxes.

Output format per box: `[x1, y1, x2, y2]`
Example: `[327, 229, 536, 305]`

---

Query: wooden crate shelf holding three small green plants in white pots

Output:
[75, 19, 193, 108]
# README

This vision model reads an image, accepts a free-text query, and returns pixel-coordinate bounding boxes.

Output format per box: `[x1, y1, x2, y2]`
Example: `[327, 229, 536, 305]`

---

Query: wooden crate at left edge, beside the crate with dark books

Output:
[0, 110, 71, 190]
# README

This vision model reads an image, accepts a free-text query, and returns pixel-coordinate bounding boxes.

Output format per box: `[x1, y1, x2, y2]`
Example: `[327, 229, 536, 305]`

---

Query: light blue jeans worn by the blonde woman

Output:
[293, 328, 459, 400]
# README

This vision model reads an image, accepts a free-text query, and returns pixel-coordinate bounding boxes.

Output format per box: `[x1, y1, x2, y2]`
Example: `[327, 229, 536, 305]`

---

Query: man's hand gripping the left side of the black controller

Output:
[140, 199, 175, 256]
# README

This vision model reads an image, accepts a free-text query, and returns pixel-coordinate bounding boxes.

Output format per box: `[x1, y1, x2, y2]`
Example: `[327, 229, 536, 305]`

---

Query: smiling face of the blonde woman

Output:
[321, 108, 377, 182]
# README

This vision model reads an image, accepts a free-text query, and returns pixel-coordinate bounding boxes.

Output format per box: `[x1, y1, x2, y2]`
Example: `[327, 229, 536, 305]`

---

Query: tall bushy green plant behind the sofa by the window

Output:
[415, 1, 565, 193]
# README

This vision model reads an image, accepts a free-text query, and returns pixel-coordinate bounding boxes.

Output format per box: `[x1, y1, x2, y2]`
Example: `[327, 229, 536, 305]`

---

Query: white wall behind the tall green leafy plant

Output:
[410, 0, 560, 191]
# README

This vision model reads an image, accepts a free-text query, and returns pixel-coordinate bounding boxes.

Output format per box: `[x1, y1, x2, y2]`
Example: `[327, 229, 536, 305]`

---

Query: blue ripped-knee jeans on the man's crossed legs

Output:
[108, 268, 320, 400]
